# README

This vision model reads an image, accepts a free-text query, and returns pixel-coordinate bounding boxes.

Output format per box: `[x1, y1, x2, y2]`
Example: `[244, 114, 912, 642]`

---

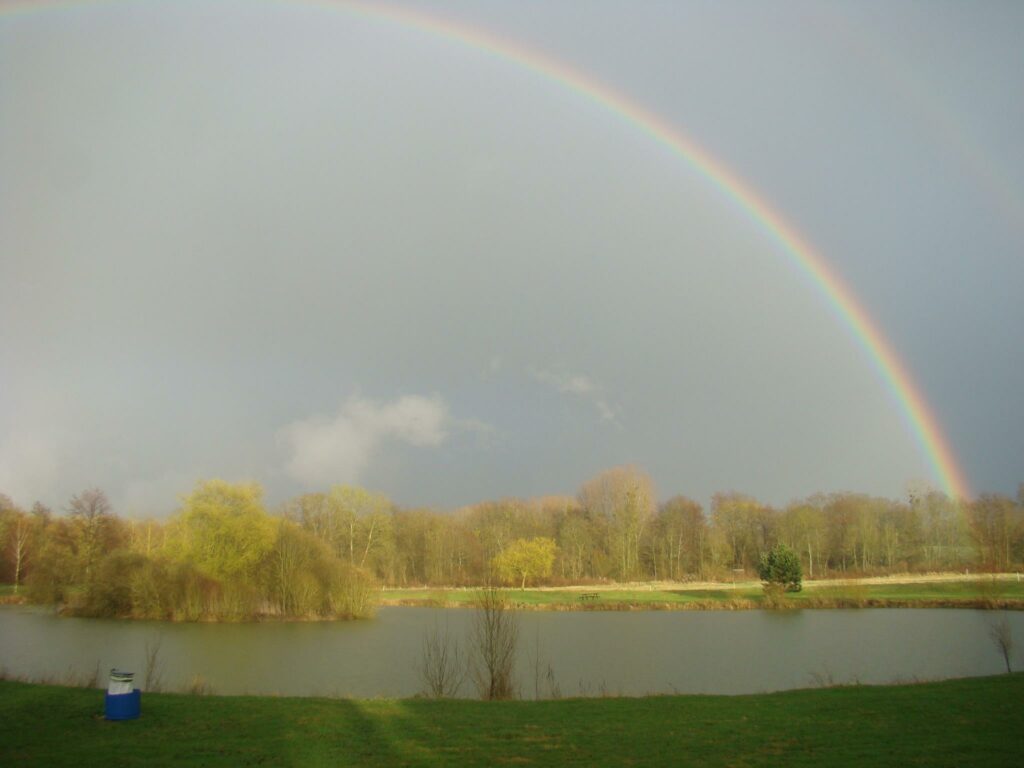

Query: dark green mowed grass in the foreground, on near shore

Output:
[0, 674, 1024, 768]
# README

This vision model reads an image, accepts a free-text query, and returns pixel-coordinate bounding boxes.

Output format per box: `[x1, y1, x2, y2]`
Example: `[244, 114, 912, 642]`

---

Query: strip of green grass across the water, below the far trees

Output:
[383, 580, 1024, 608]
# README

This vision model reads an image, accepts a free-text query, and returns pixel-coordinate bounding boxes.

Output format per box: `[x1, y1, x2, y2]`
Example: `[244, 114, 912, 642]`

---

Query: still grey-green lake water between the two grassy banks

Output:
[0, 606, 1024, 698]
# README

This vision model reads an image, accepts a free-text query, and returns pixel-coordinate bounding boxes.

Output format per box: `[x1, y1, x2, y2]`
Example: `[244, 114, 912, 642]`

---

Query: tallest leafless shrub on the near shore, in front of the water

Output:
[471, 587, 519, 700]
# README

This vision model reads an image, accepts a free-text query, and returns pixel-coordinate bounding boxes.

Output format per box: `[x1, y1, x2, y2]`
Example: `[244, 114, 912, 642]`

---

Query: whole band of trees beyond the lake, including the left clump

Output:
[0, 467, 1024, 621]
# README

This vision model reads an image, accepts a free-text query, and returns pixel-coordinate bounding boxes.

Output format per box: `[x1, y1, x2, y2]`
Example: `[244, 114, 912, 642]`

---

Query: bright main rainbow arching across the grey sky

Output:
[0, 0, 971, 499]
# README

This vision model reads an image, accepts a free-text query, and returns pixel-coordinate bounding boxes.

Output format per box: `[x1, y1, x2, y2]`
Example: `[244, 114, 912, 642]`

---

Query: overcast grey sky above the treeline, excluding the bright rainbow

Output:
[0, 0, 1024, 515]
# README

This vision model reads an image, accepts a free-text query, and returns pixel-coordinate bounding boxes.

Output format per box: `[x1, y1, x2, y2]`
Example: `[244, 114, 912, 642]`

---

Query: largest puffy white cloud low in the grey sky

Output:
[281, 395, 450, 485]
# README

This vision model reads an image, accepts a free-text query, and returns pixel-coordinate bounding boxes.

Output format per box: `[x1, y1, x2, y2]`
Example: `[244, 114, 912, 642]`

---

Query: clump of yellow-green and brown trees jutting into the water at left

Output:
[0, 480, 378, 621]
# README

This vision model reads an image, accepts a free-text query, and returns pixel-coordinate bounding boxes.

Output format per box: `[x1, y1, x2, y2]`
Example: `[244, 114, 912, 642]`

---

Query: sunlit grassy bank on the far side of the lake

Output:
[382, 579, 1024, 610]
